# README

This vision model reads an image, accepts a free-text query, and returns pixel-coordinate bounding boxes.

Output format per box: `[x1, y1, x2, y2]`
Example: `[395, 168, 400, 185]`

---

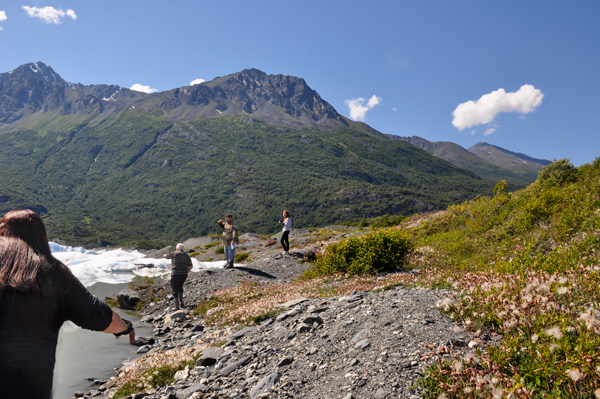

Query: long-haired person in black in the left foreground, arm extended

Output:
[0, 209, 135, 399]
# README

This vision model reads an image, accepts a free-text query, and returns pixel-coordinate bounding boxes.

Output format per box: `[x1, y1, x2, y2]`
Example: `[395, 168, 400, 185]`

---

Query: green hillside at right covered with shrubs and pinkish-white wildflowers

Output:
[407, 159, 600, 399]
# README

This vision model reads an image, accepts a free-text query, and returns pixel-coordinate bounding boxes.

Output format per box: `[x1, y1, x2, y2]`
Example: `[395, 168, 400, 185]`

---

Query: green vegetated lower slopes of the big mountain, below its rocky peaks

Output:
[0, 107, 494, 248]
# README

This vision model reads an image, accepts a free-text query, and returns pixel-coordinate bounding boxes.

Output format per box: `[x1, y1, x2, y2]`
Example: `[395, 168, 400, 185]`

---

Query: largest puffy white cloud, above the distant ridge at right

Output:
[452, 85, 544, 134]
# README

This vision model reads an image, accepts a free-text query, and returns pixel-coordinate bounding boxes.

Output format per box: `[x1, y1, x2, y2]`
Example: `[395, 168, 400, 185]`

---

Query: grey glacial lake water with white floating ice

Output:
[50, 243, 225, 399]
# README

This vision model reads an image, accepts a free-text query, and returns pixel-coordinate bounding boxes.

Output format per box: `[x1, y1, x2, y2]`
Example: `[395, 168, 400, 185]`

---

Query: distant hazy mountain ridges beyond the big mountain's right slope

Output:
[386, 134, 550, 188]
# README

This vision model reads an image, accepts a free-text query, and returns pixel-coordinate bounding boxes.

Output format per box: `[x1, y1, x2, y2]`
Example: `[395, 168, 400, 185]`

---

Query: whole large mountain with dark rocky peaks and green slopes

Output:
[0, 62, 494, 247]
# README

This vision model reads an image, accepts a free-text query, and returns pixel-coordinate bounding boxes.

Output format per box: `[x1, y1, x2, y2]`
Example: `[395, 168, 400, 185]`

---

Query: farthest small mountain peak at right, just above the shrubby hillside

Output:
[469, 143, 552, 180]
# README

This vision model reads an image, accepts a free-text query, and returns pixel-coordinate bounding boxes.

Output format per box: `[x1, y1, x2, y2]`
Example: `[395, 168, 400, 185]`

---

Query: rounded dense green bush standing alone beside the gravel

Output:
[305, 229, 411, 278]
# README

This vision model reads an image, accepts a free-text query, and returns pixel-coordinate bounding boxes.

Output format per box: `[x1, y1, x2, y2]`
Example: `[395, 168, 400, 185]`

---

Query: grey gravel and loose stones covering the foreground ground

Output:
[76, 231, 498, 399]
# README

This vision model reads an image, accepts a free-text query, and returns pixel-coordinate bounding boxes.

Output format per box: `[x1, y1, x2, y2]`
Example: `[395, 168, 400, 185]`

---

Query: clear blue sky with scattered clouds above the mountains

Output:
[0, 0, 600, 165]
